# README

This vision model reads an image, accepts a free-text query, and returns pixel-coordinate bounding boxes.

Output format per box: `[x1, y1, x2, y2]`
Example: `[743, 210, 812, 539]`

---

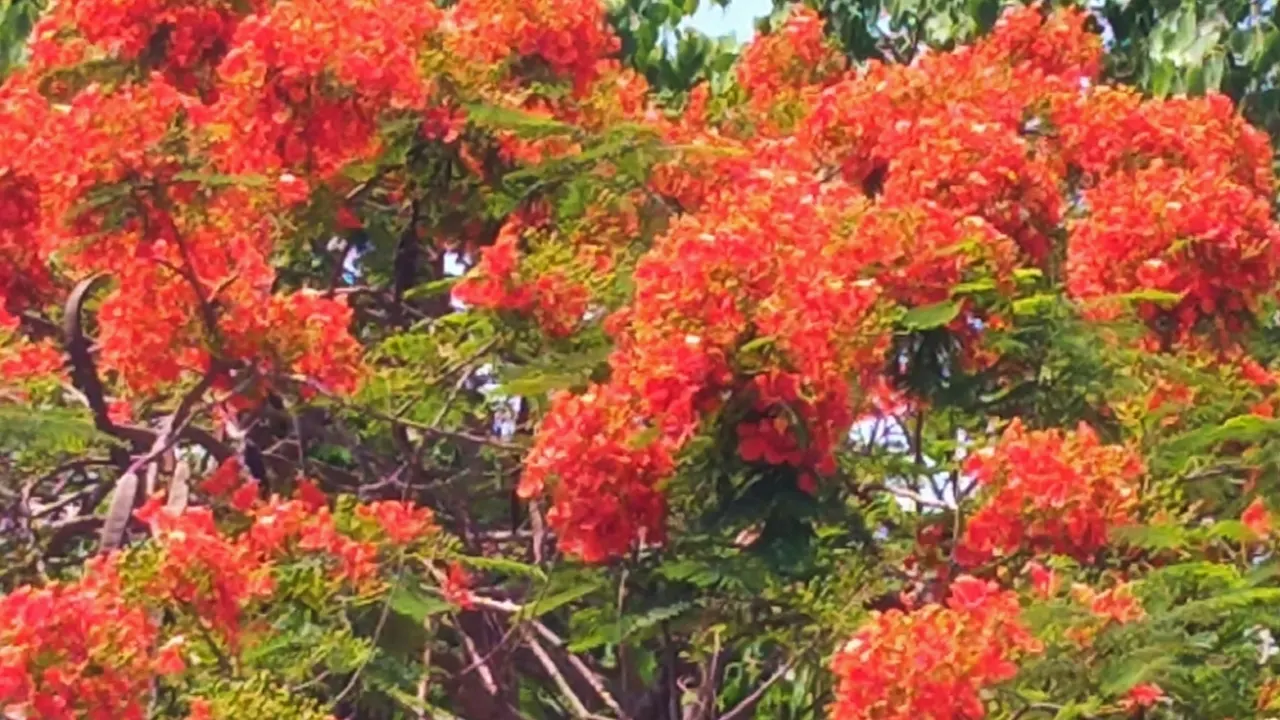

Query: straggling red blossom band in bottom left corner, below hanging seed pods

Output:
[0, 462, 436, 720]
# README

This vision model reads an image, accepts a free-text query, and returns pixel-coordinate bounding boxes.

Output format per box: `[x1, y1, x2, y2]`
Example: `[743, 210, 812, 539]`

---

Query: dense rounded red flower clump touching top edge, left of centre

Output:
[195, 0, 440, 181]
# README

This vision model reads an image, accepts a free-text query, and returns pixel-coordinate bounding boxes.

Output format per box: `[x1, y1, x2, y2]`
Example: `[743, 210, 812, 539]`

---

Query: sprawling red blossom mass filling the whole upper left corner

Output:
[0, 0, 648, 397]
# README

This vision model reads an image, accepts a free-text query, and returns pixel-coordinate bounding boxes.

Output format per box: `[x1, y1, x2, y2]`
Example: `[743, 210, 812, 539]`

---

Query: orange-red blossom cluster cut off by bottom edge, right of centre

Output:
[831, 577, 1041, 720]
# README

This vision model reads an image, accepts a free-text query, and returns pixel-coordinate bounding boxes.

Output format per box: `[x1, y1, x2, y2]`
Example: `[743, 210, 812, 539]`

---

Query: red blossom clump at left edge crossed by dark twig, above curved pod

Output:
[0, 63, 361, 395]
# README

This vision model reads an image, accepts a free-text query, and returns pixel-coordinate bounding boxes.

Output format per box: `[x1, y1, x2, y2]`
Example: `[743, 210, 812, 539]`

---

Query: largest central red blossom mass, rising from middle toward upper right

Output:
[519, 9, 1121, 559]
